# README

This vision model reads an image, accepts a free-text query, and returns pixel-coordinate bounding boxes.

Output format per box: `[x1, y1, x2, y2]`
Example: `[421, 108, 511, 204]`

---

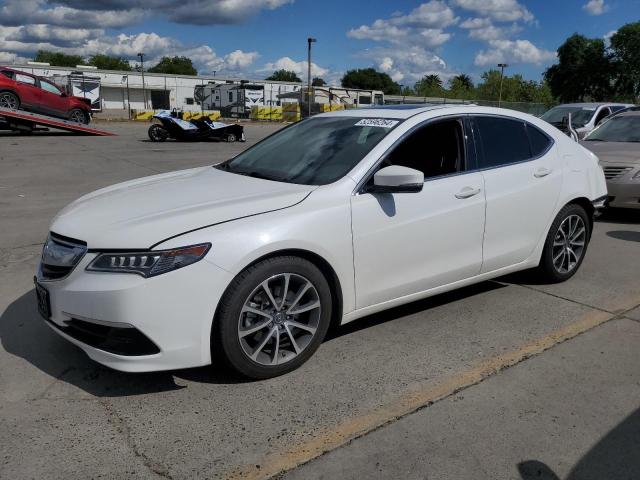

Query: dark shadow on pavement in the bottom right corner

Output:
[518, 409, 640, 480]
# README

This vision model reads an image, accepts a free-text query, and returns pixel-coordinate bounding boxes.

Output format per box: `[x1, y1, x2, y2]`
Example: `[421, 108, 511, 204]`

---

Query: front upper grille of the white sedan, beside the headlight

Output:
[40, 232, 87, 280]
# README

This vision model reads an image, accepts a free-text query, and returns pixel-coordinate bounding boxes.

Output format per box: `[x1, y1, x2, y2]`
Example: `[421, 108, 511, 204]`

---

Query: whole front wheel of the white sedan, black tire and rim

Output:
[212, 256, 332, 379]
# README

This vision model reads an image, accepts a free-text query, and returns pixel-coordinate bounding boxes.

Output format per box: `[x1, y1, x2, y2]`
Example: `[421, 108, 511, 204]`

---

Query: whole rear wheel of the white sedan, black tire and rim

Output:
[538, 203, 591, 283]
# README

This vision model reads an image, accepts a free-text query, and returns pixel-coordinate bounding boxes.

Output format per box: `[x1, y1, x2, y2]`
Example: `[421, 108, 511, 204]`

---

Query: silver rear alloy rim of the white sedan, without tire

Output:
[552, 215, 587, 274]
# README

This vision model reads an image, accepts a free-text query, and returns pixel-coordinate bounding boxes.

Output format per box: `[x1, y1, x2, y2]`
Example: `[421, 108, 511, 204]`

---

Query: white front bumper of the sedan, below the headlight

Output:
[37, 253, 232, 372]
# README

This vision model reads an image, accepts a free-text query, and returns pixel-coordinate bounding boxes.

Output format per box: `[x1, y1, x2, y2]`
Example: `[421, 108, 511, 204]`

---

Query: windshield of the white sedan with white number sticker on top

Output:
[215, 117, 400, 185]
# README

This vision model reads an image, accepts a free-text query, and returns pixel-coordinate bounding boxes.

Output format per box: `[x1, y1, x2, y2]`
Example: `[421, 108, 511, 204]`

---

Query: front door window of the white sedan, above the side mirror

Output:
[382, 120, 464, 178]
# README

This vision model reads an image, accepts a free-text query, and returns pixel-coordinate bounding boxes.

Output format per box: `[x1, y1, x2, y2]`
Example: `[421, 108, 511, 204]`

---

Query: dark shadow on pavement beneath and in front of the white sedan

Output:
[0, 282, 505, 397]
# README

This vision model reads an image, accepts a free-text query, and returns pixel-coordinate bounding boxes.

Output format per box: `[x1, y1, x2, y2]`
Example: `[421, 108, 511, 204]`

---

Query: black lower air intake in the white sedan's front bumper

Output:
[49, 318, 160, 356]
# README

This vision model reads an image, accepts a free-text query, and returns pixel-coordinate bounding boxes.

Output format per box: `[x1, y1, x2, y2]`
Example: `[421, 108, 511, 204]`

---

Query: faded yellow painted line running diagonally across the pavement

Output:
[227, 310, 620, 480]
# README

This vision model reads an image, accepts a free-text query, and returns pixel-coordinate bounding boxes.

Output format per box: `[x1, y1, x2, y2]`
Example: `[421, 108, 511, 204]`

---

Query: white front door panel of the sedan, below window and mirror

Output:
[351, 172, 485, 308]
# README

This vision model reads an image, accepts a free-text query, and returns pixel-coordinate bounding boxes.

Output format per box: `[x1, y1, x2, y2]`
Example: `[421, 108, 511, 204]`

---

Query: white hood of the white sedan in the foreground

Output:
[51, 167, 315, 249]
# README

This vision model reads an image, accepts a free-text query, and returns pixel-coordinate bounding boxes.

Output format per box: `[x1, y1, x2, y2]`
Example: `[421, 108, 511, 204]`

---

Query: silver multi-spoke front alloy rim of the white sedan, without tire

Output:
[238, 273, 321, 366]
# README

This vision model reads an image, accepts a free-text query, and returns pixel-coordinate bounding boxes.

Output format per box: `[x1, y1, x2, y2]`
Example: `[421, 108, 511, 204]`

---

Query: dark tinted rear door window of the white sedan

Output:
[476, 117, 531, 168]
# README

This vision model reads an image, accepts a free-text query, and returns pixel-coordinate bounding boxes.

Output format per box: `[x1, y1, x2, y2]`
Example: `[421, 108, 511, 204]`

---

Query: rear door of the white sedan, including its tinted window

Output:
[474, 117, 562, 273]
